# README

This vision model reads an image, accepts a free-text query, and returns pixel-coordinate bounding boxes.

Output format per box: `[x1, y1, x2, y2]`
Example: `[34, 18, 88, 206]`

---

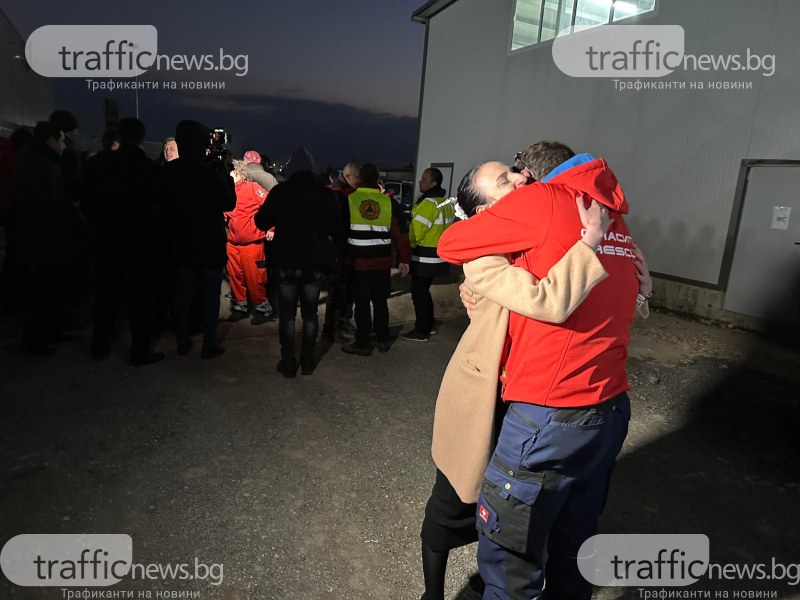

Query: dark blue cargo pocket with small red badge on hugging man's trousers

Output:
[476, 457, 544, 553]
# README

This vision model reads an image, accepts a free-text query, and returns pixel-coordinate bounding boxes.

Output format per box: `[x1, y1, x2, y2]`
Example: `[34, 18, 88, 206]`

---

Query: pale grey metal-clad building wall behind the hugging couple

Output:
[417, 0, 800, 285]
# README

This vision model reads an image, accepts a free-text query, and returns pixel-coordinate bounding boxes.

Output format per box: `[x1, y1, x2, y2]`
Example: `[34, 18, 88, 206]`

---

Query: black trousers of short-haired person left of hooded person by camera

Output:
[92, 260, 155, 359]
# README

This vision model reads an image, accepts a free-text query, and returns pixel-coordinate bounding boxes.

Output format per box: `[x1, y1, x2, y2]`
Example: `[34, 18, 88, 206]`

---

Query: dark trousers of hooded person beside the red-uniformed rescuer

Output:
[278, 268, 322, 361]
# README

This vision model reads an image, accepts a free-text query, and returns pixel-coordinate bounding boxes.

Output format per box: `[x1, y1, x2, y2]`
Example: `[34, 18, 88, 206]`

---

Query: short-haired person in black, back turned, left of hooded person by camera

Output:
[82, 118, 164, 367]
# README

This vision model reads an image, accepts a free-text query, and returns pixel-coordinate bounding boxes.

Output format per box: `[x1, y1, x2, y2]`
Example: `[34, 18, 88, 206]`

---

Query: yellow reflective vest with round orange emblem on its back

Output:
[347, 188, 392, 258]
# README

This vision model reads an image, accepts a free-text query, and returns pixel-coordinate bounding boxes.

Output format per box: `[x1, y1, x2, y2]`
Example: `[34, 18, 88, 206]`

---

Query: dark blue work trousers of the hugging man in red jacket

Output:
[477, 393, 630, 600]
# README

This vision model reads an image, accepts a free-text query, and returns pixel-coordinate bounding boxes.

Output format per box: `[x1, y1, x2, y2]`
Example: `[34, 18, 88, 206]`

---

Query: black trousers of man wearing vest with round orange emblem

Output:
[353, 269, 391, 345]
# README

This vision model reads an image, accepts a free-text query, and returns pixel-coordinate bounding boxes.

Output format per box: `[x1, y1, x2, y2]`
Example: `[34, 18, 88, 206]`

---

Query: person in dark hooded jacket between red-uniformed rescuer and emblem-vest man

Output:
[255, 147, 344, 377]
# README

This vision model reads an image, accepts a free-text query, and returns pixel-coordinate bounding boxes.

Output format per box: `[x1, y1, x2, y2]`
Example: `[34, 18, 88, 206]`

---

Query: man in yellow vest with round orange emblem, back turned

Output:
[342, 163, 411, 356]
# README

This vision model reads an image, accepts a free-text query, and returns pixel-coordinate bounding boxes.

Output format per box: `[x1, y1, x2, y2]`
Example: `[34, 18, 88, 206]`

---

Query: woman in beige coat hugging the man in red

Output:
[422, 163, 649, 600]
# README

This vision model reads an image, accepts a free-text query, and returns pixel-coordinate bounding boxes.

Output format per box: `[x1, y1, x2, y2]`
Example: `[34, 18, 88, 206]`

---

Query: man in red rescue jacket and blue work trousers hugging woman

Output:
[438, 142, 638, 599]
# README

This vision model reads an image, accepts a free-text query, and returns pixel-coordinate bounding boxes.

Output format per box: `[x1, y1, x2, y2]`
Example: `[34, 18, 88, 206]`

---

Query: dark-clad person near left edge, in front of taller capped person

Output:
[15, 121, 79, 356]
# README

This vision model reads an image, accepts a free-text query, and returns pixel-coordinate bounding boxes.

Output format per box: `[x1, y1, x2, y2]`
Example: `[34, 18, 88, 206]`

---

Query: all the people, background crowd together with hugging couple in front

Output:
[0, 111, 652, 600]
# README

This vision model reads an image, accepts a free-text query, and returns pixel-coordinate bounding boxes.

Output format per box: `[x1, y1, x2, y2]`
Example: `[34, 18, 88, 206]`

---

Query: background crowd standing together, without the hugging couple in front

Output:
[2, 111, 460, 377]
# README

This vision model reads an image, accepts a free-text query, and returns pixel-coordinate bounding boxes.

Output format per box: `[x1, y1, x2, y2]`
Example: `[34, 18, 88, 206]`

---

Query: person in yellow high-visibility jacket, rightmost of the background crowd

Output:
[400, 167, 456, 342]
